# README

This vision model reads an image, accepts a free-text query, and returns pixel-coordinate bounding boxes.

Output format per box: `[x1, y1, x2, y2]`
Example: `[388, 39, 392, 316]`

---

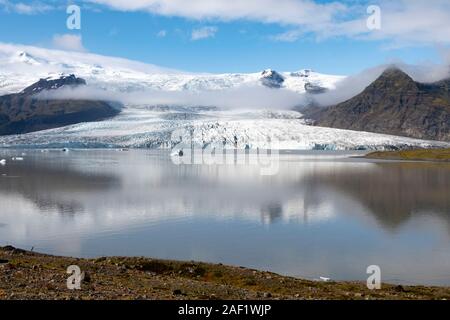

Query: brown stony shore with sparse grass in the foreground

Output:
[0, 246, 450, 300]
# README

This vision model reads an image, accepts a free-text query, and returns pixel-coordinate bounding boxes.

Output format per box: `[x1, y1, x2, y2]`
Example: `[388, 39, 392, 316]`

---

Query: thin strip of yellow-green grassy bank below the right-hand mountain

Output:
[366, 149, 450, 162]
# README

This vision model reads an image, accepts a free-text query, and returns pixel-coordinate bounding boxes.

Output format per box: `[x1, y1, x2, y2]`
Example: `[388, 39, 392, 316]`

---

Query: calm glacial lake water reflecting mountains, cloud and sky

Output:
[0, 150, 450, 285]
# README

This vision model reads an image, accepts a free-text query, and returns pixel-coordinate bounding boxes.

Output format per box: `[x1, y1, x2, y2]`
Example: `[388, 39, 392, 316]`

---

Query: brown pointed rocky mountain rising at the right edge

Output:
[303, 68, 450, 141]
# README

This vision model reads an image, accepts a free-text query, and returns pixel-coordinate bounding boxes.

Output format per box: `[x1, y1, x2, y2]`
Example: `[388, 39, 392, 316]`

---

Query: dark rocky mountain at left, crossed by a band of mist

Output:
[0, 75, 120, 135]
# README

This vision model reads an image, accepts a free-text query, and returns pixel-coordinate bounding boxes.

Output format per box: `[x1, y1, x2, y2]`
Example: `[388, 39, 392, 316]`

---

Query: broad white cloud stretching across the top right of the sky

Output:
[86, 0, 450, 46]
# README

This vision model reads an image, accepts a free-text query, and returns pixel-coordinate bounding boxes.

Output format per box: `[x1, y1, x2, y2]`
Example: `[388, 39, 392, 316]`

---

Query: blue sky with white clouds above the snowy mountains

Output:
[0, 0, 450, 75]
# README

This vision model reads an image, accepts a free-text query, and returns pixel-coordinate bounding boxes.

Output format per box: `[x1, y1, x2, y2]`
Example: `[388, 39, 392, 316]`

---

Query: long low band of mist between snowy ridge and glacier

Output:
[36, 49, 450, 109]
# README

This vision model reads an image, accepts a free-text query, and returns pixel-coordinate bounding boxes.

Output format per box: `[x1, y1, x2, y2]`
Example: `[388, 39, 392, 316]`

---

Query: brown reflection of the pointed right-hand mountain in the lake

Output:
[309, 162, 450, 229]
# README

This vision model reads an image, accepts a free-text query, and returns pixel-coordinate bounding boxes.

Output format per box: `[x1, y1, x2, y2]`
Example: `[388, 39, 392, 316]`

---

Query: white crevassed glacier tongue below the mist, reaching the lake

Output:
[0, 106, 450, 150]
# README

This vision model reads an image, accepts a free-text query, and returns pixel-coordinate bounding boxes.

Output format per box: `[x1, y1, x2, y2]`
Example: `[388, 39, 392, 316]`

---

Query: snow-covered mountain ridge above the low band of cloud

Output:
[0, 44, 344, 95]
